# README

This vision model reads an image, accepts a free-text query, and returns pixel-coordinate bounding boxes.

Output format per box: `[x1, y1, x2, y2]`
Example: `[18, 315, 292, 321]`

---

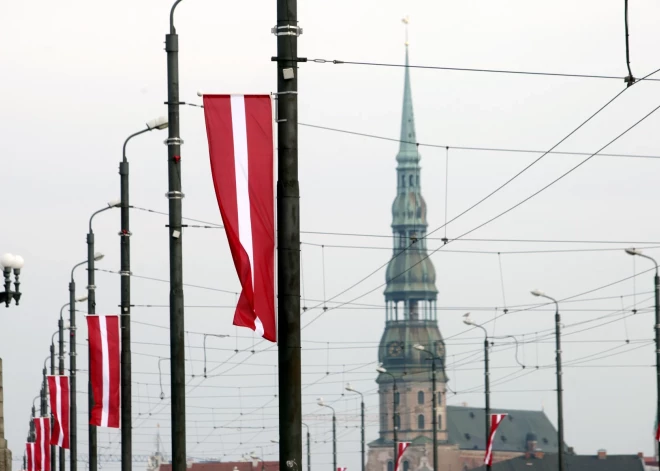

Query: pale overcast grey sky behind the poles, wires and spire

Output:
[0, 0, 660, 469]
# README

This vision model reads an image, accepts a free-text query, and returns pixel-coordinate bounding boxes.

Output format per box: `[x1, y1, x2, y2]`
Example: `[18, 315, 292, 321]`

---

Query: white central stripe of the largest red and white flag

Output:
[230, 95, 264, 336]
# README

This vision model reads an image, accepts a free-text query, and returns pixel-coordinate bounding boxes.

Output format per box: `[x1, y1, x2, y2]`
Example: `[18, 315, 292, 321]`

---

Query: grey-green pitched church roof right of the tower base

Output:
[447, 406, 558, 453]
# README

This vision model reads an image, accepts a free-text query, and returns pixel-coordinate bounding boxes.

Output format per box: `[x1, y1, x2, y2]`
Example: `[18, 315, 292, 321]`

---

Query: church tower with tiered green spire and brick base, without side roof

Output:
[367, 44, 460, 471]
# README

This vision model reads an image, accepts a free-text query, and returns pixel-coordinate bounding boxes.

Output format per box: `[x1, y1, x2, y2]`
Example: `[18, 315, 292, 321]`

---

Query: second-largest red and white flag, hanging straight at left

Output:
[87, 315, 121, 428]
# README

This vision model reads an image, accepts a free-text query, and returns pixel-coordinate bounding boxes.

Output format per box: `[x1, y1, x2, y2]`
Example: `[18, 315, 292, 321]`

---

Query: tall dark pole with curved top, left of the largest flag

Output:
[165, 0, 184, 471]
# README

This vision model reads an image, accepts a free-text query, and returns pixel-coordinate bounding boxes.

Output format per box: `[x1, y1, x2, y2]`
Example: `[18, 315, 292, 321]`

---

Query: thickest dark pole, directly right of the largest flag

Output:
[272, 0, 302, 471]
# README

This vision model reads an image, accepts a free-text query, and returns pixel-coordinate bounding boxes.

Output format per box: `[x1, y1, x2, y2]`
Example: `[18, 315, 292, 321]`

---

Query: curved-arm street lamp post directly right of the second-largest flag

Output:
[121, 117, 167, 471]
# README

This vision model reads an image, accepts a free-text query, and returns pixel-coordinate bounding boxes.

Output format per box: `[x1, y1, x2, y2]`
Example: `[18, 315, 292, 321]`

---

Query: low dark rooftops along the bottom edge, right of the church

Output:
[474, 454, 644, 471]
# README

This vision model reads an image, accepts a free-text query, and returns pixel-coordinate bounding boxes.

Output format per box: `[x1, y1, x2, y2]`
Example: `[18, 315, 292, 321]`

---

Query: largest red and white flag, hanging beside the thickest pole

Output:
[204, 95, 274, 342]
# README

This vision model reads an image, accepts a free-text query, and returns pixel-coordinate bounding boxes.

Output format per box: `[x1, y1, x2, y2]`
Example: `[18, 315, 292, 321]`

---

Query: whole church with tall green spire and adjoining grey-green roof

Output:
[367, 45, 558, 471]
